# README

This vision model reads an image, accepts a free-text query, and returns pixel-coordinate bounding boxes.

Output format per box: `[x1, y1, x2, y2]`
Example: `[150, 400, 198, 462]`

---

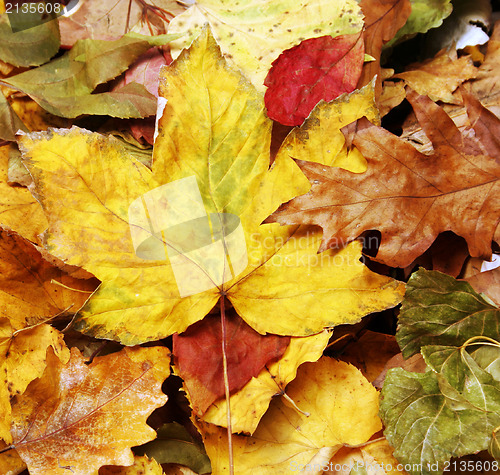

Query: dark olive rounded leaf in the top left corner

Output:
[0, 13, 60, 67]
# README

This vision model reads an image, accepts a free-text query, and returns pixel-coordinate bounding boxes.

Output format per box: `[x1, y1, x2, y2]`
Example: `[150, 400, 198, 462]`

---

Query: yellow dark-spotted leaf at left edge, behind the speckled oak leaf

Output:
[0, 324, 69, 443]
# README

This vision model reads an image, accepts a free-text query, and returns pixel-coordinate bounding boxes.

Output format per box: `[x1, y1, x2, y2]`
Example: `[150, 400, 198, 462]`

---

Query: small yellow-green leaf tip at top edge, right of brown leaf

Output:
[385, 0, 453, 48]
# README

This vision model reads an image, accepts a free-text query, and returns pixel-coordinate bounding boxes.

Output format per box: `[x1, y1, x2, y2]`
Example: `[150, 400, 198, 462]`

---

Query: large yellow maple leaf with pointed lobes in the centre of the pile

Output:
[21, 30, 404, 345]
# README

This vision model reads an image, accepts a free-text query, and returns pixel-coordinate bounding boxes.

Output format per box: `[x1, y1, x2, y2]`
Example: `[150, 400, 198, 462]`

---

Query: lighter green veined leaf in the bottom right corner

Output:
[380, 368, 500, 475]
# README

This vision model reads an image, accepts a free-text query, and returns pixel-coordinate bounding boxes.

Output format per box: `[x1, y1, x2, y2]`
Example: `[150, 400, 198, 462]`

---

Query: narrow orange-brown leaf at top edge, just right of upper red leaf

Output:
[358, 0, 411, 99]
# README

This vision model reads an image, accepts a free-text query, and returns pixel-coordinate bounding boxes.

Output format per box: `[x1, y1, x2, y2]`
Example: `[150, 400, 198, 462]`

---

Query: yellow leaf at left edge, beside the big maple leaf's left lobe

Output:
[0, 145, 47, 242]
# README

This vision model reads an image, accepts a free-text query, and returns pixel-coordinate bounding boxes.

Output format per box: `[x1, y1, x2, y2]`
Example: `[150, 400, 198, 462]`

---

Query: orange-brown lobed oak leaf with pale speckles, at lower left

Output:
[11, 347, 170, 475]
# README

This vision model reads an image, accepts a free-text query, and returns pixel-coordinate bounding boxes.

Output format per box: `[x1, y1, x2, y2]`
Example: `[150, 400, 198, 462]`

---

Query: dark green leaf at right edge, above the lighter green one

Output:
[396, 269, 500, 358]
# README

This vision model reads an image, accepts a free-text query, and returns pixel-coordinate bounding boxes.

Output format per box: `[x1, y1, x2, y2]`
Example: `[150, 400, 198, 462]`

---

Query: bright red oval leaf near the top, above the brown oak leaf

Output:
[264, 34, 365, 125]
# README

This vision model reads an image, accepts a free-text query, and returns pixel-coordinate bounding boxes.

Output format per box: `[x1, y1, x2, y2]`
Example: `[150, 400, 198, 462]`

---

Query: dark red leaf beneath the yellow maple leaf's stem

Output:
[173, 313, 290, 415]
